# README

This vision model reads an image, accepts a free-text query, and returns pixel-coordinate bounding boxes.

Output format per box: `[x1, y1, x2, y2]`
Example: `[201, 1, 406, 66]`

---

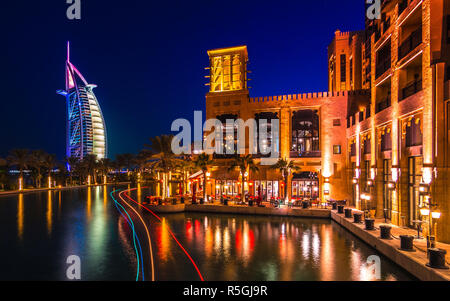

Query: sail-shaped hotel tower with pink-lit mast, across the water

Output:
[57, 43, 107, 159]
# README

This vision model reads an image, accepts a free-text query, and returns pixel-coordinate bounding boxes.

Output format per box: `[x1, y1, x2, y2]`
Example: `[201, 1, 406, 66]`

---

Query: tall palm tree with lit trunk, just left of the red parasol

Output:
[145, 135, 178, 199]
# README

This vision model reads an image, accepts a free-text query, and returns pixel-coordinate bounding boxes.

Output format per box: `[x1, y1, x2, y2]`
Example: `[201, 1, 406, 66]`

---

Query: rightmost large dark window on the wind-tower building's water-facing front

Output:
[291, 110, 321, 158]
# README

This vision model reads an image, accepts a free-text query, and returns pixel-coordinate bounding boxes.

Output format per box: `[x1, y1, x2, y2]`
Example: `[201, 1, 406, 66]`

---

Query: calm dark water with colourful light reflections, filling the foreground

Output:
[0, 187, 413, 281]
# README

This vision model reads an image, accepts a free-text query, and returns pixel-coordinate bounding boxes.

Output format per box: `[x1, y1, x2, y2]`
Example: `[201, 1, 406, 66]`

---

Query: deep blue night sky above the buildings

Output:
[0, 0, 365, 158]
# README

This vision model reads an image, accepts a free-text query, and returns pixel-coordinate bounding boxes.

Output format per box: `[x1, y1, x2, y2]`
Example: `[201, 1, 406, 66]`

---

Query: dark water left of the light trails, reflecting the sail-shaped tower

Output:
[0, 186, 135, 281]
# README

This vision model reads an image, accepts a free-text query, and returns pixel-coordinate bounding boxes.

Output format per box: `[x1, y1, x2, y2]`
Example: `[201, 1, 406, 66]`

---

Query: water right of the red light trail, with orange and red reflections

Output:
[155, 214, 411, 281]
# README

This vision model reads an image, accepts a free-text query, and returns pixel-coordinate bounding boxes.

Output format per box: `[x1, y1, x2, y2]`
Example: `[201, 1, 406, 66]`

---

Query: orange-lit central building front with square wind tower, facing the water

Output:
[206, 46, 369, 204]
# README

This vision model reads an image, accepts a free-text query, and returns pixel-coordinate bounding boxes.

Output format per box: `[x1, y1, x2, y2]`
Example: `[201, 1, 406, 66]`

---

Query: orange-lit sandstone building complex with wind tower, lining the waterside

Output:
[206, 0, 450, 242]
